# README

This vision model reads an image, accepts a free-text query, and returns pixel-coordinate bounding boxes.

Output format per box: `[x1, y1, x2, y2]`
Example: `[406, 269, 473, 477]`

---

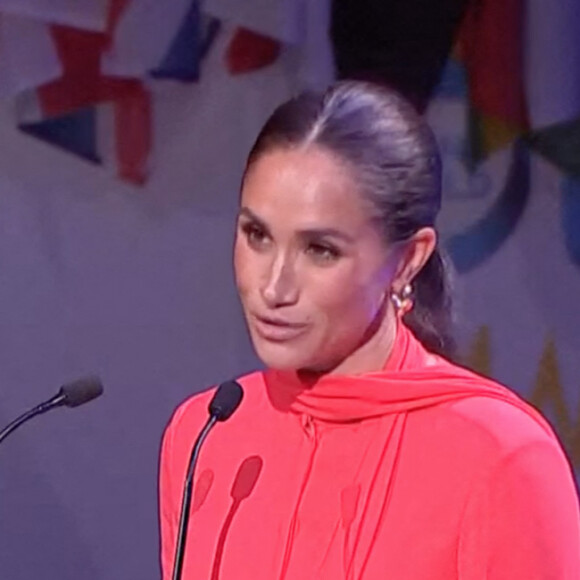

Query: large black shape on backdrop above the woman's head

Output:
[331, 0, 469, 112]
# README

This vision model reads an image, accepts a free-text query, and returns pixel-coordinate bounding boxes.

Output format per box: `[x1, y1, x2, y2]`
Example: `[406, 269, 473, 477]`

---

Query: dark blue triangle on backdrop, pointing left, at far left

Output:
[18, 107, 101, 164]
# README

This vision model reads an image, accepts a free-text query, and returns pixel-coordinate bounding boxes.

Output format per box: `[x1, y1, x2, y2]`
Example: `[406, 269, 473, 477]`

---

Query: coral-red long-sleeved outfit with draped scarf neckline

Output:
[160, 325, 580, 580]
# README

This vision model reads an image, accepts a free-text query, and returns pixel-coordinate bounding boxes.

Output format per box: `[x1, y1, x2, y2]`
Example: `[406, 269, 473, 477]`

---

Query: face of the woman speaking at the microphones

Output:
[234, 147, 397, 373]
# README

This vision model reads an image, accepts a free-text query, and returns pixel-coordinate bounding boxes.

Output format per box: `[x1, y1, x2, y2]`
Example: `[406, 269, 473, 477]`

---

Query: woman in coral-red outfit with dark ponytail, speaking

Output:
[160, 82, 580, 580]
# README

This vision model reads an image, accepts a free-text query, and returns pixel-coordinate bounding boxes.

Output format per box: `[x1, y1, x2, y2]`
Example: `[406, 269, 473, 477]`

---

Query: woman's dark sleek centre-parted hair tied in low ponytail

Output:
[246, 81, 455, 356]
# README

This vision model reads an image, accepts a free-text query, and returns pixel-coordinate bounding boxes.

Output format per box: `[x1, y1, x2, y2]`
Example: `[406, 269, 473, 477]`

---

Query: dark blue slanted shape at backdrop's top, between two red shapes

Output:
[150, 0, 220, 83]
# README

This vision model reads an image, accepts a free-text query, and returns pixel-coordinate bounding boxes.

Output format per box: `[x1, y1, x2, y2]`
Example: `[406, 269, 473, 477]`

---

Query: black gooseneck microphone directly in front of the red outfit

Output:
[173, 381, 244, 580]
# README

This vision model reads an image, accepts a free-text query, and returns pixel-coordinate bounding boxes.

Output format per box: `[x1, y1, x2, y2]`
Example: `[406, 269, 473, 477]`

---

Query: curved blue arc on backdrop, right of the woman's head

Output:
[445, 140, 530, 274]
